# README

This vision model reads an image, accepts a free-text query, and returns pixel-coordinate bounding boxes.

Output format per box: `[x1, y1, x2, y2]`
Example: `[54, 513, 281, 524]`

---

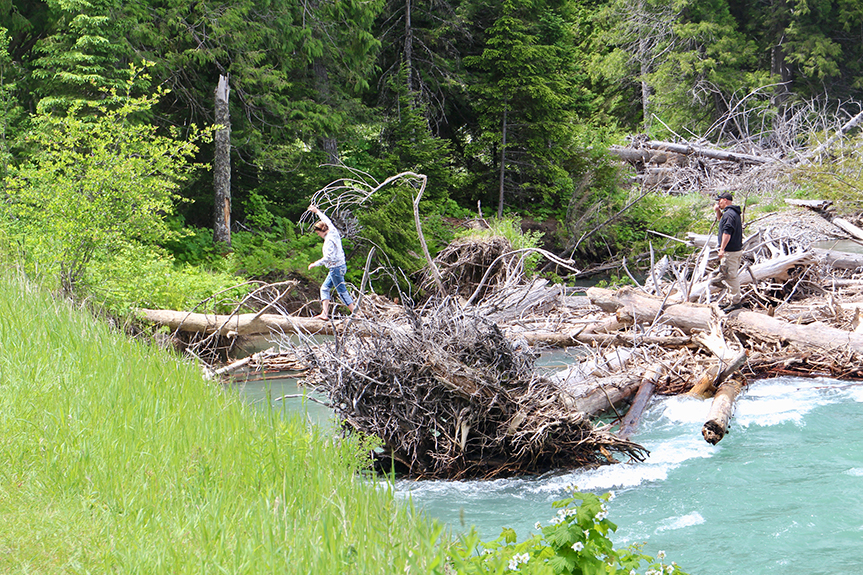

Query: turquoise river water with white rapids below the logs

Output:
[235, 362, 863, 575]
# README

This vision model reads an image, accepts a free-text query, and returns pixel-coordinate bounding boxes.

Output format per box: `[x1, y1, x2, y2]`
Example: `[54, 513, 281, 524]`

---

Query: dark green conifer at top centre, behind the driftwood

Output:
[465, 0, 589, 216]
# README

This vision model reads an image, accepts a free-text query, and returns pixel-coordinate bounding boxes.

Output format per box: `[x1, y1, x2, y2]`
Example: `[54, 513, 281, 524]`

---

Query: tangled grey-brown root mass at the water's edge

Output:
[300, 300, 647, 479]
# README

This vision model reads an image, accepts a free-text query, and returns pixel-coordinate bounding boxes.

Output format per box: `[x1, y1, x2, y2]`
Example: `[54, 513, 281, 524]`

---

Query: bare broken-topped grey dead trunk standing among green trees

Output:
[213, 75, 231, 250]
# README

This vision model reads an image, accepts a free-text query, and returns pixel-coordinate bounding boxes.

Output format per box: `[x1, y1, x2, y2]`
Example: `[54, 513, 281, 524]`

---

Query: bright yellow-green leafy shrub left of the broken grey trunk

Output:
[6, 66, 211, 293]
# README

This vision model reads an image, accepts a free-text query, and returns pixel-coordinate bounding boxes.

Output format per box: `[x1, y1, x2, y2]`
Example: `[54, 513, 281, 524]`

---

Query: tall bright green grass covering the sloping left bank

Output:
[0, 271, 441, 575]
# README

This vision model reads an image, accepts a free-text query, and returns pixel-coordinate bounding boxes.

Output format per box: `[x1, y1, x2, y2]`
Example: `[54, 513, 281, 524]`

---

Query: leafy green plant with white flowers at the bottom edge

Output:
[449, 488, 684, 575]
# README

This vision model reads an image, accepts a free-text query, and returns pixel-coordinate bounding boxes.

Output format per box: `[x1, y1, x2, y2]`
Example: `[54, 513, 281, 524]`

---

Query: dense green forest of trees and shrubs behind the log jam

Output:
[0, 0, 863, 312]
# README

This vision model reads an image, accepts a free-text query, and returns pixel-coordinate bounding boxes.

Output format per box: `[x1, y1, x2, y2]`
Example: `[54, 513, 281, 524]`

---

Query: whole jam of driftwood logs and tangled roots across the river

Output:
[135, 196, 863, 479]
